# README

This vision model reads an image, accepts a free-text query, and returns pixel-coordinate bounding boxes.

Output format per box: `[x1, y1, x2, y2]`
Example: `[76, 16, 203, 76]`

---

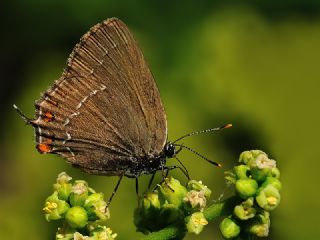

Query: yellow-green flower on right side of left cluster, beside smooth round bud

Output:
[84, 193, 110, 221]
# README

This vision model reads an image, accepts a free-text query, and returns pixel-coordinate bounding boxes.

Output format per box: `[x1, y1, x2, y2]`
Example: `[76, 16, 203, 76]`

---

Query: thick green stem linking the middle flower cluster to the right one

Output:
[141, 197, 238, 240]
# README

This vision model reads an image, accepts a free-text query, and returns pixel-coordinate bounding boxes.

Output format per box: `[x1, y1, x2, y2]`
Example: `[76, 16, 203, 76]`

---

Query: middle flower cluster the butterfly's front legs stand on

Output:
[134, 177, 211, 239]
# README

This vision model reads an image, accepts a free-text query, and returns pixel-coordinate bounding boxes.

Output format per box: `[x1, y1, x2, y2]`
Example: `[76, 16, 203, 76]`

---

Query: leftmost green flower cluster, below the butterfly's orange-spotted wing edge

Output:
[43, 172, 117, 240]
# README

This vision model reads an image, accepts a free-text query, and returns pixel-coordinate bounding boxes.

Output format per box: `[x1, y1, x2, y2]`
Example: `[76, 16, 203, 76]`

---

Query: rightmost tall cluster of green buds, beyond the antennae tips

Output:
[220, 150, 281, 238]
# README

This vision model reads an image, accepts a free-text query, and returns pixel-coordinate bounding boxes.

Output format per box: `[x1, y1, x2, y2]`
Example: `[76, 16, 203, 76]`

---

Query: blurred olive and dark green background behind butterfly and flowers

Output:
[0, 0, 320, 240]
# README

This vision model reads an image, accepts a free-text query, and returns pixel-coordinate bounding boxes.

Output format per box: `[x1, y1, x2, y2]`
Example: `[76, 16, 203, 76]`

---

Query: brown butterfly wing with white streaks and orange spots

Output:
[33, 18, 167, 175]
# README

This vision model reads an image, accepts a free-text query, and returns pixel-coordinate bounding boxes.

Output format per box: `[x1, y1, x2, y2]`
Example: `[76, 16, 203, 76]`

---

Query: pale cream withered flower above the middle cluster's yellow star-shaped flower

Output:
[183, 190, 207, 212]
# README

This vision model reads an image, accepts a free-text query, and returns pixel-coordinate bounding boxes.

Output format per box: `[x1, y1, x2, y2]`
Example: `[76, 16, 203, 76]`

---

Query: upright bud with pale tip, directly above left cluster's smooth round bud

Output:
[69, 180, 89, 206]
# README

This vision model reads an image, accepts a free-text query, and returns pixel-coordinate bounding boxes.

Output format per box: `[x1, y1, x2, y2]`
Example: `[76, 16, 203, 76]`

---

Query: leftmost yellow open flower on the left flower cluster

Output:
[43, 192, 69, 222]
